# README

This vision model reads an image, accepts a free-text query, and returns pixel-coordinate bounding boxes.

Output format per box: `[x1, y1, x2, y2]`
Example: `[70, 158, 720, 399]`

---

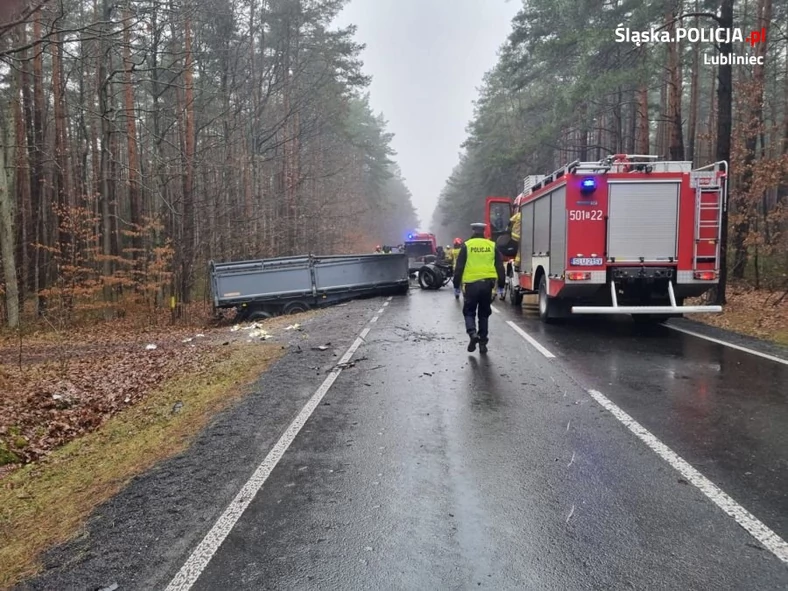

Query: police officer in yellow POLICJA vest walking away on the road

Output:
[454, 224, 506, 353]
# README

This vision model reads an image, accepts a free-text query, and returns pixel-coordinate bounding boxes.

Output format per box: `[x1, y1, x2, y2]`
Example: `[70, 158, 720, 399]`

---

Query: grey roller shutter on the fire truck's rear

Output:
[607, 181, 681, 261]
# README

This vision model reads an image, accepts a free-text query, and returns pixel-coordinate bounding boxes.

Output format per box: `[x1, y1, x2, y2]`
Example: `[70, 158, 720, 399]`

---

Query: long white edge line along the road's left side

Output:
[166, 308, 388, 591]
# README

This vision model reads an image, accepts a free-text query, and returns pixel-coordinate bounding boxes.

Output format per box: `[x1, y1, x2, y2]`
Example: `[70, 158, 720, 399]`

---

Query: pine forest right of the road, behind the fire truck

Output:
[432, 0, 788, 303]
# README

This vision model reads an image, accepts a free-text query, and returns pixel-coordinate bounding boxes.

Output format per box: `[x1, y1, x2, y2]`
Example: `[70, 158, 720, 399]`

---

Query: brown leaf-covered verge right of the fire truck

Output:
[692, 286, 788, 345]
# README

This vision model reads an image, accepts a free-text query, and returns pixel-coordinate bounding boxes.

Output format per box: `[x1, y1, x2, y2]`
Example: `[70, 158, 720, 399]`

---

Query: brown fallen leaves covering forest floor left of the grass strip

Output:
[0, 308, 304, 478]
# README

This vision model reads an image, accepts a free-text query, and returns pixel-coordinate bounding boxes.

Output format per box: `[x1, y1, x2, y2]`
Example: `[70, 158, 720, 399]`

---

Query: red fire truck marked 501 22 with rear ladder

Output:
[488, 154, 728, 322]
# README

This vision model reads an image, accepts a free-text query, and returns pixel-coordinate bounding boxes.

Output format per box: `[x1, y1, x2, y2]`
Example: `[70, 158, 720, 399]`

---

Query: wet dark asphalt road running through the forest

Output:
[21, 289, 788, 591]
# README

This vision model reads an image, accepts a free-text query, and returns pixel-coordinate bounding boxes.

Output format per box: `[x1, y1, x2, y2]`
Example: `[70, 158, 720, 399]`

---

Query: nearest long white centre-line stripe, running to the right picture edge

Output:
[588, 390, 788, 564]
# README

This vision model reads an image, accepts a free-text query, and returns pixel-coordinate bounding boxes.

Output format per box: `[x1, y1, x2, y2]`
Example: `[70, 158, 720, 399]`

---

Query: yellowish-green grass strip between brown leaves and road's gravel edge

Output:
[0, 342, 284, 589]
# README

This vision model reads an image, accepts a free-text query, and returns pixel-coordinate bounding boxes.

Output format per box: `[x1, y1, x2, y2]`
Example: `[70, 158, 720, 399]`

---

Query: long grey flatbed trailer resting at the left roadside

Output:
[209, 254, 409, 321]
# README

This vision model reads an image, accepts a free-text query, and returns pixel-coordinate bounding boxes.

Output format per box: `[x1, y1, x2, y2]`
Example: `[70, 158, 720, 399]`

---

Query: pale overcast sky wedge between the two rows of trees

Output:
[336, 0, 522, 229]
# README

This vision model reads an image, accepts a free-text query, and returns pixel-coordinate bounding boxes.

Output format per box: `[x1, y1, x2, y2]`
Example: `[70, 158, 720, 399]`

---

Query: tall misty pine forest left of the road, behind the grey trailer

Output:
[0, 0, 417, 327]
